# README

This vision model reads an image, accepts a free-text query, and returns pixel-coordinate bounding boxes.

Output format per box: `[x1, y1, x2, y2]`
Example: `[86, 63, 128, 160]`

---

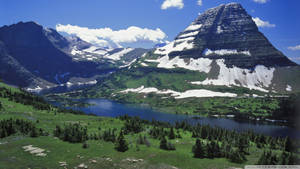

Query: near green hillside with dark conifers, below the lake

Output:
[0, 84, 299, 168]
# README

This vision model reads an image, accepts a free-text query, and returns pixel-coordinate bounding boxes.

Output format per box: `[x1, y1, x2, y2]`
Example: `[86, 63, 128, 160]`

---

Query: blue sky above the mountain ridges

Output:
[0, 0, 300, 63]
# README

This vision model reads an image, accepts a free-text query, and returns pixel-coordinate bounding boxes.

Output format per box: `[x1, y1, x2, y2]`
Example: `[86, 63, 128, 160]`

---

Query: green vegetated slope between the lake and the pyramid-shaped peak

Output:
[49, 67, 300, 125]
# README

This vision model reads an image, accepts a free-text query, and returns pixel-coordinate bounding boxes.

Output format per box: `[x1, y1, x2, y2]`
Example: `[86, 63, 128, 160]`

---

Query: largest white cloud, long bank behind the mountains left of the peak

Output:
[56, 24, 167, 48]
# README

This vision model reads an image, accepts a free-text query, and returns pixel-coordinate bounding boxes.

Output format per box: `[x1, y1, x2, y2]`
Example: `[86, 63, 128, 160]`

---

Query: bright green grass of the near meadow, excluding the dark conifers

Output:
[0, 84, 290, 169]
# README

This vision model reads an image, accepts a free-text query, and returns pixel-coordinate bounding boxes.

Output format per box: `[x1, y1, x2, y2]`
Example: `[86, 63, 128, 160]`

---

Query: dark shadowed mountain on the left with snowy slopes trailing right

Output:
[0, 22, 147, 88]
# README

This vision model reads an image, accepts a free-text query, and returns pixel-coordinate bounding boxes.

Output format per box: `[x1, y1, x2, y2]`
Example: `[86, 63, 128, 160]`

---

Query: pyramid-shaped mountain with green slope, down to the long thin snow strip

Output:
[81, 3, 300, 99]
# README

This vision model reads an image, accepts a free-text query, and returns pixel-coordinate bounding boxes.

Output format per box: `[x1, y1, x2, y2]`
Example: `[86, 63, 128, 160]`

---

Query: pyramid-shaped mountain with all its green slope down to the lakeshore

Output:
[45, 3, 300, 125]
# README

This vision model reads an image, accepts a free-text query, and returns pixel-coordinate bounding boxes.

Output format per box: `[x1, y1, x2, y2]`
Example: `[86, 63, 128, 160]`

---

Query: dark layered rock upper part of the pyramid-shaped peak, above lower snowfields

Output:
[156, 3, 296, 69]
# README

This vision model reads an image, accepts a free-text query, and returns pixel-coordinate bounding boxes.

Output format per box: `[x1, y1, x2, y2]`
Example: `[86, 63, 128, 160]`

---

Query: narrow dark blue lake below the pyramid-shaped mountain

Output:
[70, 99, 300, 138]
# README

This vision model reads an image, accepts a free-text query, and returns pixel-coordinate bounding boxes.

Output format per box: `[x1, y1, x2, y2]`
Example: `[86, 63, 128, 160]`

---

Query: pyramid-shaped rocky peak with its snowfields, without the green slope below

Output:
[134, 3, 300, 92]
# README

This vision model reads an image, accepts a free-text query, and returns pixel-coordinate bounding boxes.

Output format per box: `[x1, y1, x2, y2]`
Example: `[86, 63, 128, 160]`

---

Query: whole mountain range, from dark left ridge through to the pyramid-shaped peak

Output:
[0, 3, 300, 98]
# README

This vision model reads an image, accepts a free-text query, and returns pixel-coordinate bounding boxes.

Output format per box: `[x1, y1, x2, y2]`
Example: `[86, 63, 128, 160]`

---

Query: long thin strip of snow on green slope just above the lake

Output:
[120, 86, 237, 99]
